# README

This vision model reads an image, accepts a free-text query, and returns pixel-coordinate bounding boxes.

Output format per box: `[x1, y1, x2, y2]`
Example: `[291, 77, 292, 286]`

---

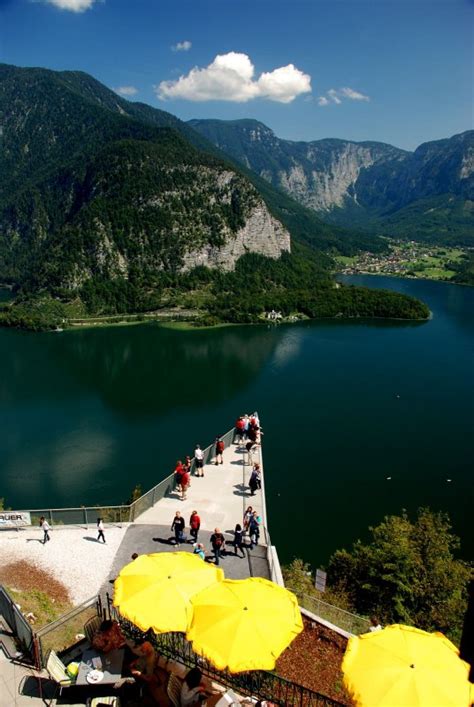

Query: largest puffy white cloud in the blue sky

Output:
[155, 52, 311, 103]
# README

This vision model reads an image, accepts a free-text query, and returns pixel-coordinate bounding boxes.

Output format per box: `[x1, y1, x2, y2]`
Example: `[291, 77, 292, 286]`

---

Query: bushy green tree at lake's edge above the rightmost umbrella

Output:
[328, 508, 472, 641]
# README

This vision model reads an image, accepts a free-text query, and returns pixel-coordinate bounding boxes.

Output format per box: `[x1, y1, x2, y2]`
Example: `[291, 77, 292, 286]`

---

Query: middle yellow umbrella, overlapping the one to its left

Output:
[186, 577, 303, 673]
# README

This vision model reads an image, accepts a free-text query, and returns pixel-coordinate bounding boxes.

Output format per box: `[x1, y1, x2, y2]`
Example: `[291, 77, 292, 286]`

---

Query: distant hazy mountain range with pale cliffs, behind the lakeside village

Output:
[189, 120, 474, 245]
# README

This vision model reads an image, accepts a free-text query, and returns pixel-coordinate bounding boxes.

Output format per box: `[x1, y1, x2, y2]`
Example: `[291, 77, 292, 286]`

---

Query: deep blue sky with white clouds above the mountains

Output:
[0, 0, 474, 149]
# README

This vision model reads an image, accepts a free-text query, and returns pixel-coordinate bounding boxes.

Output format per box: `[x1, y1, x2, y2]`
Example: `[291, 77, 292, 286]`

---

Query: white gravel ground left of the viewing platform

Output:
[0, 525, 128, 605]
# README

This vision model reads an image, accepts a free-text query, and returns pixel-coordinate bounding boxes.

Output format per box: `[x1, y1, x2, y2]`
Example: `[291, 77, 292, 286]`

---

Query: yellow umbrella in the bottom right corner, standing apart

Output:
[342, 624, 470, 707]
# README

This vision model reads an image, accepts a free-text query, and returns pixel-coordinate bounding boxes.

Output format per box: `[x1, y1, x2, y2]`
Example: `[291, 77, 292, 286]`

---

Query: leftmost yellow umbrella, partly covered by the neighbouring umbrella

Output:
[114, 552, 224, 633]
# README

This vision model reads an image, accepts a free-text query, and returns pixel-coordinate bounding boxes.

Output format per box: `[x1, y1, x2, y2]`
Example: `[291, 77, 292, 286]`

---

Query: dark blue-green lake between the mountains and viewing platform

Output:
[0, 276, 474, 566]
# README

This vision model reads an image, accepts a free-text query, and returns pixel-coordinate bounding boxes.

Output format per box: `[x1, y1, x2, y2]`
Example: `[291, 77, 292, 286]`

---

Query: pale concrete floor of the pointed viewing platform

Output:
[135, 444, 266, 544]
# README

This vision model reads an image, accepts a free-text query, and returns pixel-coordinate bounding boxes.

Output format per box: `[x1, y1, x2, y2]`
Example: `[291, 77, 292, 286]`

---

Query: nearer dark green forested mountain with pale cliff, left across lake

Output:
[0, 65, 427, 327]
